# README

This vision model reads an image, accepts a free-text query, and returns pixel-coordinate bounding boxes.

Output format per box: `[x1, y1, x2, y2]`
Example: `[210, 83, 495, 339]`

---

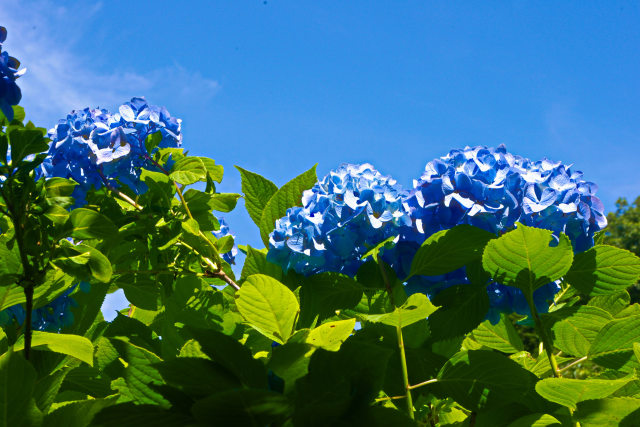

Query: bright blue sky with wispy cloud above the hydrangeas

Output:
[0, 0, 640, 314]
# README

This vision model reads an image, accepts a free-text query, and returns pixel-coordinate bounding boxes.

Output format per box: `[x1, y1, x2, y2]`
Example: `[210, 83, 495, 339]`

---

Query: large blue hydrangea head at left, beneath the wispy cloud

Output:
[42, 98, 182, 205]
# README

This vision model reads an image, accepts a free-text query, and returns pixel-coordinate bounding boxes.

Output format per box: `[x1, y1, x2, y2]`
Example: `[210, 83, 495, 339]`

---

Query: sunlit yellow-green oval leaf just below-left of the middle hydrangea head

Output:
[235, 274, 300, 344]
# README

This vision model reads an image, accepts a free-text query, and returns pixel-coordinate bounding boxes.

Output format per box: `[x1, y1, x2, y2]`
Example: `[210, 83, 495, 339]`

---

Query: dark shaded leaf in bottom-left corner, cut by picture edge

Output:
[0, 350, 36, 427]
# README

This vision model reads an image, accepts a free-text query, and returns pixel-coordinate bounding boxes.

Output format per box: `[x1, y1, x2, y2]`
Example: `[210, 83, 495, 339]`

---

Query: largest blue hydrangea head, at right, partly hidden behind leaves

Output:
[406, 145, 607, 322]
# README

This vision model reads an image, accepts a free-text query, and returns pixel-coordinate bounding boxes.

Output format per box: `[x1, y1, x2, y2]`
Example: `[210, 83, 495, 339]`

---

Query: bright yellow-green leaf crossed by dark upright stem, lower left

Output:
[14, 331, 93, 366]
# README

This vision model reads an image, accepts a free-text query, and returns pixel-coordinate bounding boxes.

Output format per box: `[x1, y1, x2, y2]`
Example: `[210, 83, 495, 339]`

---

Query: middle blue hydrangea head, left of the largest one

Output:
[267, 164, 411, 275]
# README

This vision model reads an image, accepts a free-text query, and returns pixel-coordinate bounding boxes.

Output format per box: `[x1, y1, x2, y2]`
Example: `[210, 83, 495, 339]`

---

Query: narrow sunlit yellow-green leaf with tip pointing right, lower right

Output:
[536, 375, 636, 410]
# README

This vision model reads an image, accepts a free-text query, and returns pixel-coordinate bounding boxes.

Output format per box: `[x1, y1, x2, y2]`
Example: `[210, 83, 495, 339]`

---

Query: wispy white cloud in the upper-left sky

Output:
[0, 0, 220, 126]
